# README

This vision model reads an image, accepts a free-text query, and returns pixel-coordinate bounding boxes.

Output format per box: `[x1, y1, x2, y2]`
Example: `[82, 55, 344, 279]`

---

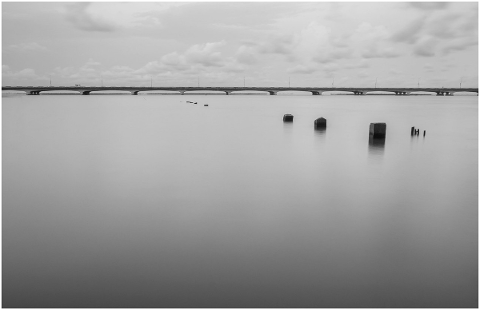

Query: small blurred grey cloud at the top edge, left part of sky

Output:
[66, 2, 118, 32]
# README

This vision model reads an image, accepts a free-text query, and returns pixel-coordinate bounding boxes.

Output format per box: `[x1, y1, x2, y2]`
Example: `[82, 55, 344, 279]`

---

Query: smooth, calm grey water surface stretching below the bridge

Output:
[2, 95, 478, 308]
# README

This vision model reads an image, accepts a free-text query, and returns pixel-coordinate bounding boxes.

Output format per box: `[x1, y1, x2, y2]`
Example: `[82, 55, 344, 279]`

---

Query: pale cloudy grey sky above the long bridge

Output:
[2, 2, 478, 87]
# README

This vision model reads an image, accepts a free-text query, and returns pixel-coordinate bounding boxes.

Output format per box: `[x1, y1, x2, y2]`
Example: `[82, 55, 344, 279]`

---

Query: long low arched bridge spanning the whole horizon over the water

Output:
[2, 86, 478, 96]
